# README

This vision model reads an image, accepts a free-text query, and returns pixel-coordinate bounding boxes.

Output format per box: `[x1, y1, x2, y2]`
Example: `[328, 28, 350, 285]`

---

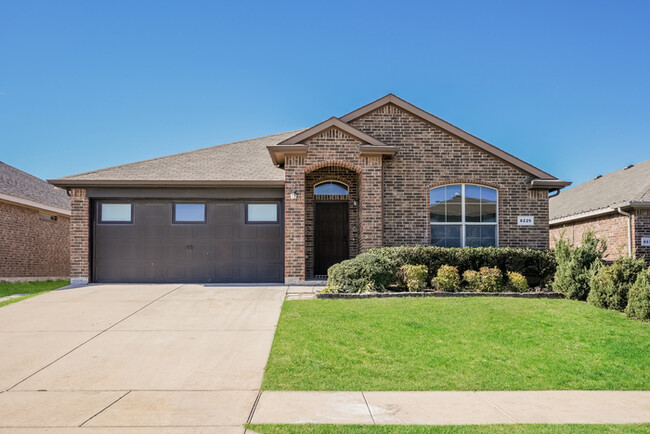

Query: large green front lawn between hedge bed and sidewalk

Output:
[262, 298, 650, 391]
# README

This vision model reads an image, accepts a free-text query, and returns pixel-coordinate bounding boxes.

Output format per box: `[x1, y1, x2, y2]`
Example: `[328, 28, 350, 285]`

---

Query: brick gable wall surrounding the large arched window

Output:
[351, 104, 548, 248]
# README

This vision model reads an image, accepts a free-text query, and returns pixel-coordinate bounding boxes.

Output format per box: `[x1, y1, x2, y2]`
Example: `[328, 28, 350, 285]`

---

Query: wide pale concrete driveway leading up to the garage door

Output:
[0, 284, 286, 433]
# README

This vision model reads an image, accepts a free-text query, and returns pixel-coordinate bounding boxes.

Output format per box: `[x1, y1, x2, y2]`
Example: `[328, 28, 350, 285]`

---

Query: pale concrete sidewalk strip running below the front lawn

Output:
[252, 391, 650, 425]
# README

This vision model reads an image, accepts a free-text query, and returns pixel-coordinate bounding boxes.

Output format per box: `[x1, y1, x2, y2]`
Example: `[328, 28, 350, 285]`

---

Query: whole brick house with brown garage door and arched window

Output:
[50, 95, 569, 283]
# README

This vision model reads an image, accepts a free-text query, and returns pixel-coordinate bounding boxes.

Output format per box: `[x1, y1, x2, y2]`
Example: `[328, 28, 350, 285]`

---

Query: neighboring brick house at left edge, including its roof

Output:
[0, 161, 70, 281]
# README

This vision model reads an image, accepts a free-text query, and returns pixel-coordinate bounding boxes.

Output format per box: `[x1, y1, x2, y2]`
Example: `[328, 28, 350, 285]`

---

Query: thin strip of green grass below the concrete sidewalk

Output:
[246, 424, 650, 434]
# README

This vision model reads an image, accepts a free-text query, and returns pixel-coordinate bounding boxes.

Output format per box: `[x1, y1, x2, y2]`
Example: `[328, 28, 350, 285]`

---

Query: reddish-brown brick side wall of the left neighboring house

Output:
[0, 202, 70, 279]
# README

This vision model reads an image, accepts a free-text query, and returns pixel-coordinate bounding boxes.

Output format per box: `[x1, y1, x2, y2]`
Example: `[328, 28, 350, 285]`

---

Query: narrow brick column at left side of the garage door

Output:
[70, 188, 90, 285]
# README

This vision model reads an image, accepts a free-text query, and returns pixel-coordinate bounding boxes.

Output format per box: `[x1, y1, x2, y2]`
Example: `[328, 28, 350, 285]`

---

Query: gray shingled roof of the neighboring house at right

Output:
[549, 160, 650, 220]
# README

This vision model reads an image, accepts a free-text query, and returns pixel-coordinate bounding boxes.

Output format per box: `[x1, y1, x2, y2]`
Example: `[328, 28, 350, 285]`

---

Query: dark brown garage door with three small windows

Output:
[92, 200, 284, 283]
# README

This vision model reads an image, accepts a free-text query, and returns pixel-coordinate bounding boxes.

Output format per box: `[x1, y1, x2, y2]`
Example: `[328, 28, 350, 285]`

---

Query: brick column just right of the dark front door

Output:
[359, 155, 383, 253]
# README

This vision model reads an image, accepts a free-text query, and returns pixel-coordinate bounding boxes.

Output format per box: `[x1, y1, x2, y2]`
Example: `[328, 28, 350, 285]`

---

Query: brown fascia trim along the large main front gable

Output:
[340, 94, 557, 179]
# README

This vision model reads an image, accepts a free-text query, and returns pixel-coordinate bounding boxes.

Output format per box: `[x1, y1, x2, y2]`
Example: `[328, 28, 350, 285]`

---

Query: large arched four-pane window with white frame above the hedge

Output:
[429, 184, 498, 247]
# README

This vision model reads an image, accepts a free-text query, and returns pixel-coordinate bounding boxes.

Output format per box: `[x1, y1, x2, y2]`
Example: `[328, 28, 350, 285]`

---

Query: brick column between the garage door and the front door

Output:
[284, 156, 305, 283]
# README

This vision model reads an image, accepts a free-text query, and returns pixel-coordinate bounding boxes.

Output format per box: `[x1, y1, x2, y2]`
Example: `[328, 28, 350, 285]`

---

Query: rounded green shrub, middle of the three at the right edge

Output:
[587, 256, 646, 311]
